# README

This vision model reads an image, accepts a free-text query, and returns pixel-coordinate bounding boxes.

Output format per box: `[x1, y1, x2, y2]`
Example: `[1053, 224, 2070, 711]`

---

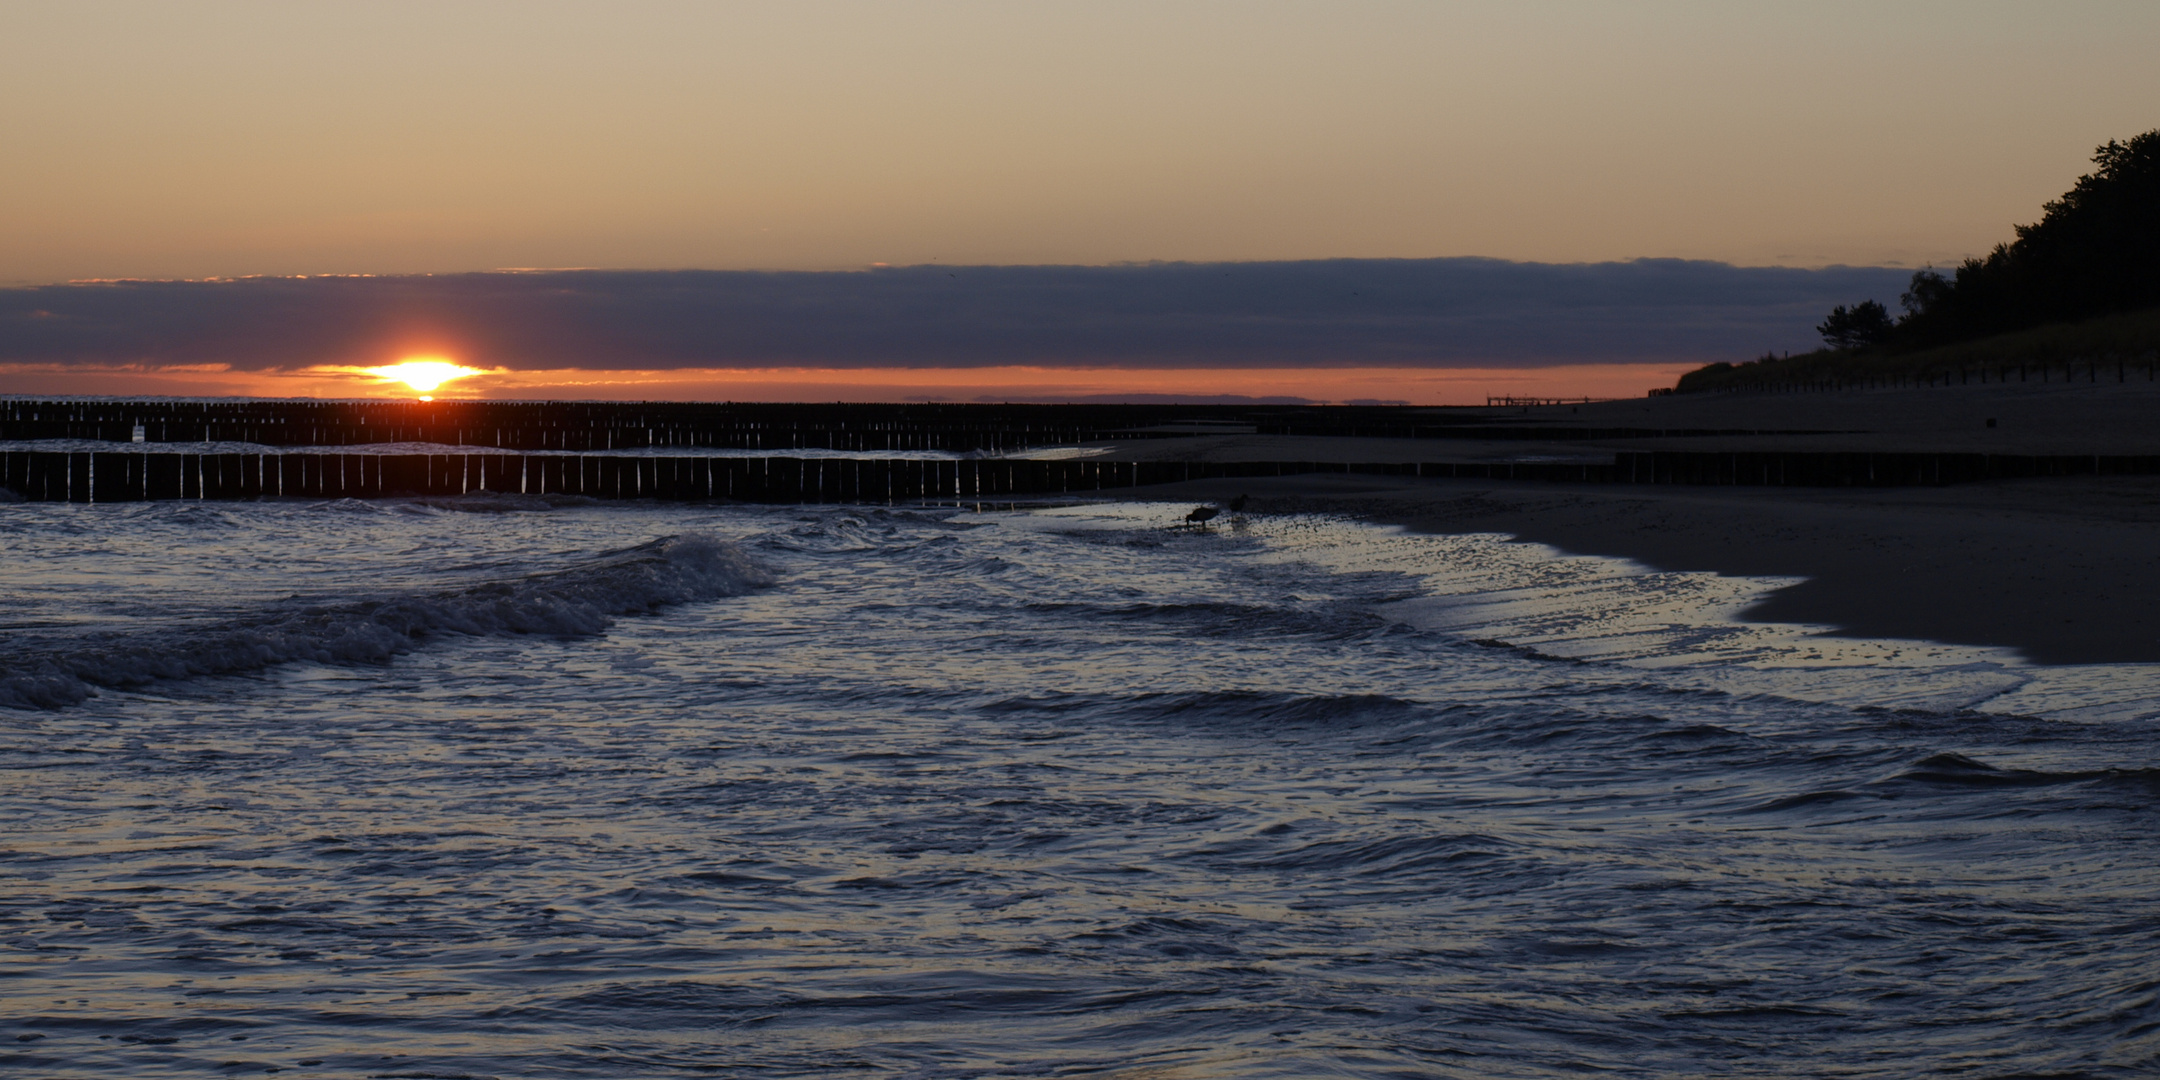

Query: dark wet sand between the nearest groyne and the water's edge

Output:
[1119, 473, 2160, 665]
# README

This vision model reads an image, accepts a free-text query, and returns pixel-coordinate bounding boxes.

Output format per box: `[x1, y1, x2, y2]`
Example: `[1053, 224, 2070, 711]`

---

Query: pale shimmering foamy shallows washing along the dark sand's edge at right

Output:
[1010, 503, 2160, 721]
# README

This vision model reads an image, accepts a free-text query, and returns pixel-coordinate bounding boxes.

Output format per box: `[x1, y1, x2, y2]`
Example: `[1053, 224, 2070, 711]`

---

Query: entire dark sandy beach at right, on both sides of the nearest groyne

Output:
[1108, 380, 2160, 663]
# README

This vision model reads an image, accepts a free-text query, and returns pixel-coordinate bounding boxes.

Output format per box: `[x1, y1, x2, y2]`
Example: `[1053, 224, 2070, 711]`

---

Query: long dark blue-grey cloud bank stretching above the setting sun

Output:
[0, 259, 1909, 369]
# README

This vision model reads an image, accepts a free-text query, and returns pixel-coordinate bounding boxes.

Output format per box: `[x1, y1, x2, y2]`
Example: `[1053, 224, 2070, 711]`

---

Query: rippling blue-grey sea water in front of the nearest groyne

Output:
[0, 497, 2160, 1078]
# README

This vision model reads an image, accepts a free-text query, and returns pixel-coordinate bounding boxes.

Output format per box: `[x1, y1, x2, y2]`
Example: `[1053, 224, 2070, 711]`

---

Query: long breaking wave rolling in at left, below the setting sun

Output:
[0, 536, 773, 708]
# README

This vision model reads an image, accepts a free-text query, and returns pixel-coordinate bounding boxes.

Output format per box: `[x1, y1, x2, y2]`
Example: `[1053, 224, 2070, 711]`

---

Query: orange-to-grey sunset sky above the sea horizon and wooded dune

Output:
[0, 0, 2160, 400]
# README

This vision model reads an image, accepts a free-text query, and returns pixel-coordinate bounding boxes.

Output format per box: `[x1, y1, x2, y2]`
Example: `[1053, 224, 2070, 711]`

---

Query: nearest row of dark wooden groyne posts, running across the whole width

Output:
[0, 451, 2160, 503]
